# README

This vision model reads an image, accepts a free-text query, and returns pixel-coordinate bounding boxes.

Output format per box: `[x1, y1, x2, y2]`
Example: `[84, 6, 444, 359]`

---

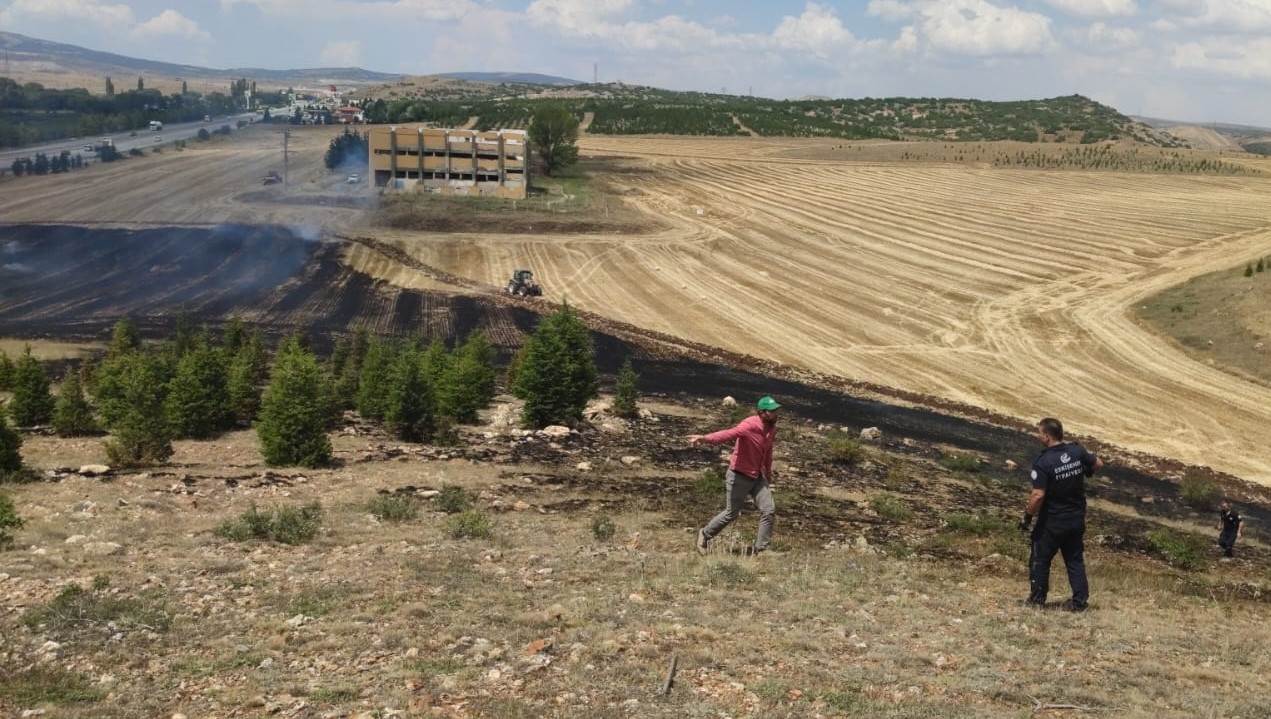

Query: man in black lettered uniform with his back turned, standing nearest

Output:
[1019, 417, 1103, 611]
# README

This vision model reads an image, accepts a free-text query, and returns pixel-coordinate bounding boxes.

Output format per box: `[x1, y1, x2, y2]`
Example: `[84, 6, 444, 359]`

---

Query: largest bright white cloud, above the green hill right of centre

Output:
[867, 0, 1055, 57]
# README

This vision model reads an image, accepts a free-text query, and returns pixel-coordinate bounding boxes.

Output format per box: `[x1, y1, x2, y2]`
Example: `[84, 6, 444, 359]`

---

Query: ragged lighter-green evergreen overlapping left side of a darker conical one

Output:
[99, 352, 173, 467]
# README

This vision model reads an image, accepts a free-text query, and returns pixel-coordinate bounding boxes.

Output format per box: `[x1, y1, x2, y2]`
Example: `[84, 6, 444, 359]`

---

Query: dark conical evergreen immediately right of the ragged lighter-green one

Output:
[164, 335, 234, 440]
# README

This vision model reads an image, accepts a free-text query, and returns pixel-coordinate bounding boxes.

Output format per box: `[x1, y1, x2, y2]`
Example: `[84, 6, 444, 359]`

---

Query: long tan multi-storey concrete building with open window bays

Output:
[367, 124, 530, 199]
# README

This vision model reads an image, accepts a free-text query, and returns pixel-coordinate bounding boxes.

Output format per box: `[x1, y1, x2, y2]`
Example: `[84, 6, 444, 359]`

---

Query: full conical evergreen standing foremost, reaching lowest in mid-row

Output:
[255, 338, 332, 467]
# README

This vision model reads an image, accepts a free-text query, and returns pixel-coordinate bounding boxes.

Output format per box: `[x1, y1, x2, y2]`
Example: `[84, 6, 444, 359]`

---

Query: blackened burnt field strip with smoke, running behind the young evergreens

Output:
[0, 225, 1271, 533]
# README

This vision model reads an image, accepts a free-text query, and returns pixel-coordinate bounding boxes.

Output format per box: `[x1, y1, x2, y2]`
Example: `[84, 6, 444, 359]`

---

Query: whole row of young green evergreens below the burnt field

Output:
[0, 305, 637, 481]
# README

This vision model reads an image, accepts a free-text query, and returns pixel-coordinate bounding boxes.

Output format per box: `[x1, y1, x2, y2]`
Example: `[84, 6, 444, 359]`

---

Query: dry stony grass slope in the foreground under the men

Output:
[0, 403, 1271, 719]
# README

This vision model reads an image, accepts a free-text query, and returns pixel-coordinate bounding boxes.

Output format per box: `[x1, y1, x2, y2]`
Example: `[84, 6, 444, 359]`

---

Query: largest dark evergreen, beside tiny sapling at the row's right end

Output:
[516, 305, 600, 427]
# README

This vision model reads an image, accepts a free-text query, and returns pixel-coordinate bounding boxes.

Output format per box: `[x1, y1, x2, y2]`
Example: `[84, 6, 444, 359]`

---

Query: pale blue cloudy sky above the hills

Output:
[0, 0, 1271, 127]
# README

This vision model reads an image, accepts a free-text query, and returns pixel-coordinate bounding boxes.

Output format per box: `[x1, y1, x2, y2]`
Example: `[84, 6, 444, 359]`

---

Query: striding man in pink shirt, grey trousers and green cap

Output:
[689, 396, 782, 554]
